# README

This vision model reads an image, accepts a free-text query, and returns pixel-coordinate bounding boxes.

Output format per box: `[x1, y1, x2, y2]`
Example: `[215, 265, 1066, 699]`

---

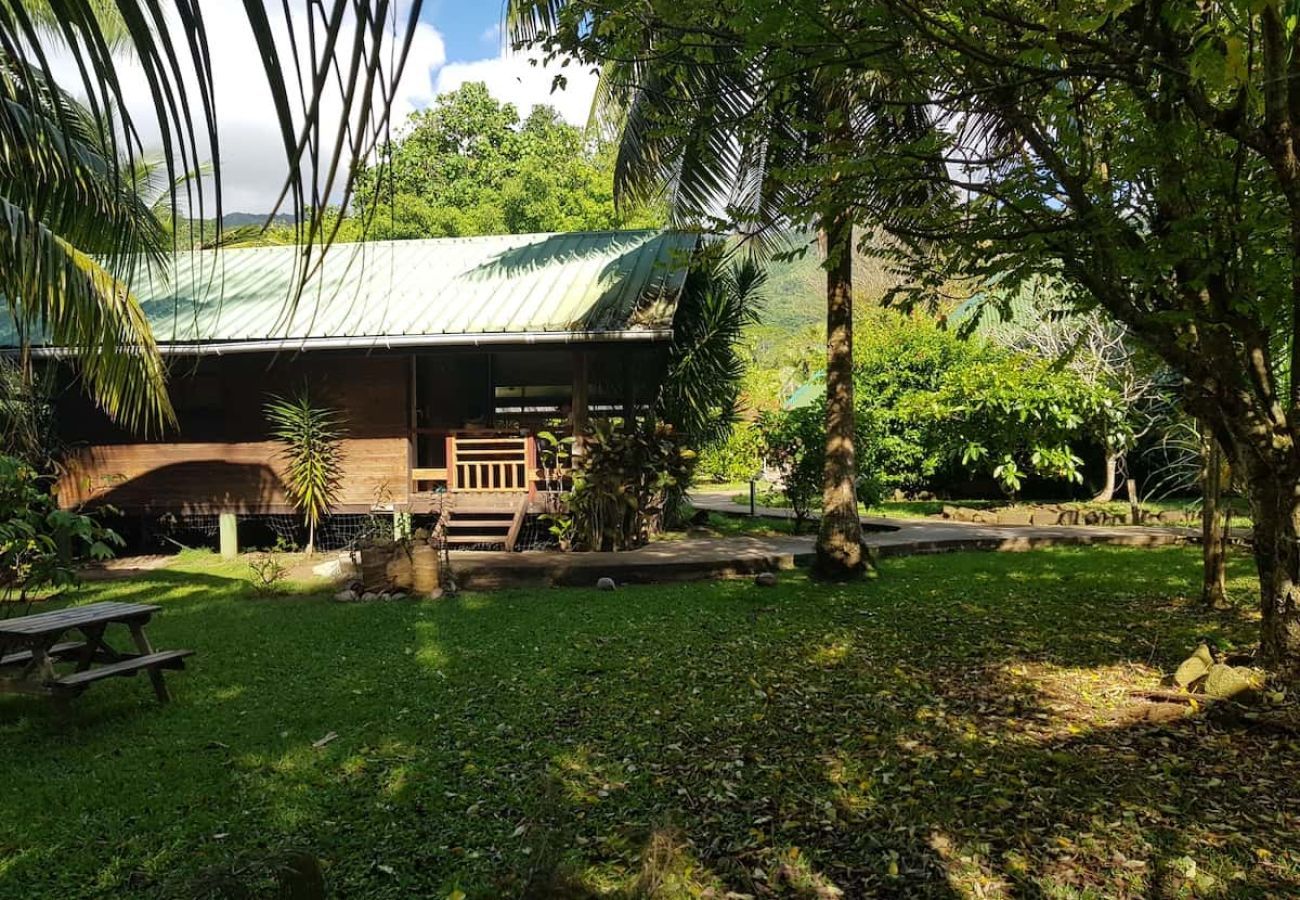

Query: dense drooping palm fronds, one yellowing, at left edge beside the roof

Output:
[0, 62, 170, 425]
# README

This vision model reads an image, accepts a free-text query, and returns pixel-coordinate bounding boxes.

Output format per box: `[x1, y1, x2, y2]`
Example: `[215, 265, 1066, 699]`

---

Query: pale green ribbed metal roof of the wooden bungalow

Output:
[0, 232, 697, 352]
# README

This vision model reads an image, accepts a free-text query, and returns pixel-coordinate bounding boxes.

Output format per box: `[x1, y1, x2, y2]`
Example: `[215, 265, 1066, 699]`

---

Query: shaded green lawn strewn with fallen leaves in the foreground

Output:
[0, 548, 1300, 899]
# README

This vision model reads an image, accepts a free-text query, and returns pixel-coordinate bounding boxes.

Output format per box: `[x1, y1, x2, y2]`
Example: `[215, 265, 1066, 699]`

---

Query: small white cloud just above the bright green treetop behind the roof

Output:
[436, 49, 597, 125]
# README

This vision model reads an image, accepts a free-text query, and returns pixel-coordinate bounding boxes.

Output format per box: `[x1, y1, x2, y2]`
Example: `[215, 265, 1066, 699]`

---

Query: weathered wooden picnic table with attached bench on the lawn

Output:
[0, 602, 194, 704]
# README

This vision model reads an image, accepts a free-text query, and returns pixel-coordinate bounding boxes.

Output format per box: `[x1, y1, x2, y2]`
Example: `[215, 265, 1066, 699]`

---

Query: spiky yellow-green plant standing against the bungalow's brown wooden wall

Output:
[264, 386, 347, 554]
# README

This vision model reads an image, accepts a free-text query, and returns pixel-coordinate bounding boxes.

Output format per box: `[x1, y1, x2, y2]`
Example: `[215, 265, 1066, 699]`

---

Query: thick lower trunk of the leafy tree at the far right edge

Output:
[1247, 464, 1300, 680]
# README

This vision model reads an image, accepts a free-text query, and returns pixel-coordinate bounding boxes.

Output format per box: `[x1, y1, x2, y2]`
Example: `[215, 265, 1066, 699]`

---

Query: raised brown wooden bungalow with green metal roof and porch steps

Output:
[12, 232, 696, 545]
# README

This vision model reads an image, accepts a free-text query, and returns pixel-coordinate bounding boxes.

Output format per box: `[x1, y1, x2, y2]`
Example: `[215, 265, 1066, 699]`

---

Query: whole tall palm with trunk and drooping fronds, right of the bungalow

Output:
[507, 0, 928, 577]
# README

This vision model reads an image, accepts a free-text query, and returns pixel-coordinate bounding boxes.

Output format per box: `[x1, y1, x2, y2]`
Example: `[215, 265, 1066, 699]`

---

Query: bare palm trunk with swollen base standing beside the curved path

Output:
[813, 209, 867, 579]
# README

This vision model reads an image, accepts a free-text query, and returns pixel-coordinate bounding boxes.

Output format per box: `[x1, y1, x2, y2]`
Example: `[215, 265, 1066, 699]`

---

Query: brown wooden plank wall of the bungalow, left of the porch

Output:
[59, 354, 411, 514]
